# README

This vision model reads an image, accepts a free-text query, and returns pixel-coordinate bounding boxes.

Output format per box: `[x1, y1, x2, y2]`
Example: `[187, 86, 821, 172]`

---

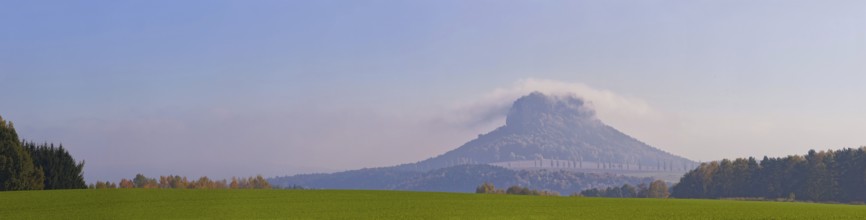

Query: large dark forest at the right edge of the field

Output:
[673, 147, 866, 202]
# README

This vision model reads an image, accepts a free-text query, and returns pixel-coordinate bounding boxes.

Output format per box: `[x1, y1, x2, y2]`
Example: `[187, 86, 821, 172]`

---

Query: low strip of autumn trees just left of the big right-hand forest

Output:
[572, 180, 670, 198]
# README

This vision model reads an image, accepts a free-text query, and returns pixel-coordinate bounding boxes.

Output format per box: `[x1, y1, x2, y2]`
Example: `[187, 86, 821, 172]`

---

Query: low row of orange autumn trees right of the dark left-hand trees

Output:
[88, 174, 271, 189]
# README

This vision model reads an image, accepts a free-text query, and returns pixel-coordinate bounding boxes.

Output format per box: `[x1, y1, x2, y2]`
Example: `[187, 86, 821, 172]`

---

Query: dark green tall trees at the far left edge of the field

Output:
[0, 117, 87, 191]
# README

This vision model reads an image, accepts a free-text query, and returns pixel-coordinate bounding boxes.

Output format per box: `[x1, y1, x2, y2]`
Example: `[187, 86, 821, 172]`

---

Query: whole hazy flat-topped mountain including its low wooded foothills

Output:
[269, 92, 697, 194]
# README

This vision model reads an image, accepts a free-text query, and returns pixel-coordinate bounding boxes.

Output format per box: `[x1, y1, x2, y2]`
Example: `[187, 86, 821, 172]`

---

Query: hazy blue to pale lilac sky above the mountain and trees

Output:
[0, 0, 866, 181]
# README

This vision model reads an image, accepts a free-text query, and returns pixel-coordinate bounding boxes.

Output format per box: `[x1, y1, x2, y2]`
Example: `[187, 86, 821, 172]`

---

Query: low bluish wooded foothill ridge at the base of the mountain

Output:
[269, 165, 652, 195]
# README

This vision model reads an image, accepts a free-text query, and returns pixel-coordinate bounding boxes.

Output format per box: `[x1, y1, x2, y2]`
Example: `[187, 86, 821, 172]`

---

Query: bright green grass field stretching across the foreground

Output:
[0, 189, 866, 219]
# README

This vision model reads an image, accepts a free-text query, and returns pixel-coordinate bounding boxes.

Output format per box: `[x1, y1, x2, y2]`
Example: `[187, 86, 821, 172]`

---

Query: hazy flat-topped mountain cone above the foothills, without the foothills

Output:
[400, 92, 694, 172]
